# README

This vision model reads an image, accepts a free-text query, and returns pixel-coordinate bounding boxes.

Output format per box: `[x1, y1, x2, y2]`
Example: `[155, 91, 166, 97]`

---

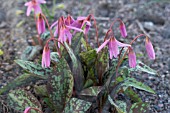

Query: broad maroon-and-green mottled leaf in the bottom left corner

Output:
[6, 89, 42, 113]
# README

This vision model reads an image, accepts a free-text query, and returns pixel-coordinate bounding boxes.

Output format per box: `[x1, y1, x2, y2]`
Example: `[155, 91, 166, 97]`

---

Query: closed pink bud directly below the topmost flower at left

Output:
[37, 13, 45, 34]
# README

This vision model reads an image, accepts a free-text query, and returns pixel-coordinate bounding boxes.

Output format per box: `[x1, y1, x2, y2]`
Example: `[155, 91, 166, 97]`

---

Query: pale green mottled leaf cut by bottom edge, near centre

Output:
[64, 98, 92, 113]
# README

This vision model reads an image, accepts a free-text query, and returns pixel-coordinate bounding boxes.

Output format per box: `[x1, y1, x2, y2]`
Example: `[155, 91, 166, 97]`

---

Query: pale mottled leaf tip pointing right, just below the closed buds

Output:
[129, 60, 158, 75]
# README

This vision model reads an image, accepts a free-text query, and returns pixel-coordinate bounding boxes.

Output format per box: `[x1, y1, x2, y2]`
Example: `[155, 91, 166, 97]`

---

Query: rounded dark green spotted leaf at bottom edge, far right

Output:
[129, 102, 149, 113]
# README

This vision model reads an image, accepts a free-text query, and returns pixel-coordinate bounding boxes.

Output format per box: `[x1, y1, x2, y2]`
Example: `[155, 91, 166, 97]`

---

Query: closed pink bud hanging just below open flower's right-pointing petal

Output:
[128, 47, 136, 68]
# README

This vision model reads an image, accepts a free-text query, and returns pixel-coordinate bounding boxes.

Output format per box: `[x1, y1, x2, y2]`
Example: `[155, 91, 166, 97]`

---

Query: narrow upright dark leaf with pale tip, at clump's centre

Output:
[65, 43, 84, 92]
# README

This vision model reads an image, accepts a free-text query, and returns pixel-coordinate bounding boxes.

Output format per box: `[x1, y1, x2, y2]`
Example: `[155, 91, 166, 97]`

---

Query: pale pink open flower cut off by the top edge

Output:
[25, 0, 46, 16]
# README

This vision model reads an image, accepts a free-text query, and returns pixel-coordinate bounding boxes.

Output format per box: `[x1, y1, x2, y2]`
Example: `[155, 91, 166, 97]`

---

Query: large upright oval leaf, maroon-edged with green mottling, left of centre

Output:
[47, 58, 73, 113]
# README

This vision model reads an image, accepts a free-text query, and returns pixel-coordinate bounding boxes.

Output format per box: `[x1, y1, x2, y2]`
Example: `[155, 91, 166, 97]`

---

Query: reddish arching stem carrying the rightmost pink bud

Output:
[116, 34, 147, 77]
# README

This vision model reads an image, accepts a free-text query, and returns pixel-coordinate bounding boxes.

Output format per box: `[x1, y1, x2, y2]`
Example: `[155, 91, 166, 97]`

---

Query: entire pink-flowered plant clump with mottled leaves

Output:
[0, 0, 157, 113]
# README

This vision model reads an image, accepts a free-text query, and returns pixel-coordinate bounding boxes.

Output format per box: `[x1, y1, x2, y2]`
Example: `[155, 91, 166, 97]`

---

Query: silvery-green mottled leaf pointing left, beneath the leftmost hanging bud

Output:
[15, 60, 53, 78]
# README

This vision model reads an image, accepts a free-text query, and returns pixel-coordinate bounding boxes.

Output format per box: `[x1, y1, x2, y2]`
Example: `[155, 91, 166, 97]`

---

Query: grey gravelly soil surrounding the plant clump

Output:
[0, 0, 170, 113]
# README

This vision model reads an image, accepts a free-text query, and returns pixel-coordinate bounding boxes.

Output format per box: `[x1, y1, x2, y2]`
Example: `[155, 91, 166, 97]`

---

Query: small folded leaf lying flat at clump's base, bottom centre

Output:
[80, 86, 102, 96]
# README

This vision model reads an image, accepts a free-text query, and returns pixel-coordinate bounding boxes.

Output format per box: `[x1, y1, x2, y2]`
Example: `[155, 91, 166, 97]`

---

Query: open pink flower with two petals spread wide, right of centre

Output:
[97, 37, 131, 59]
